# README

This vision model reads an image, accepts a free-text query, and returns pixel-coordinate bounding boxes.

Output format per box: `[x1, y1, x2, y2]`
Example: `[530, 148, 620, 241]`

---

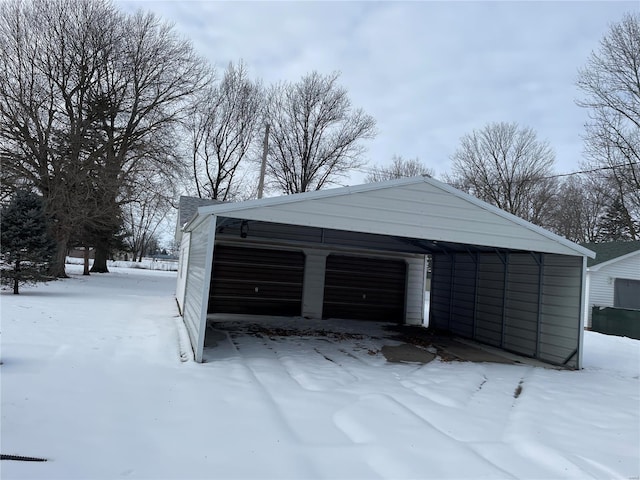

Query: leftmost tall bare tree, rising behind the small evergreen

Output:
[0, 0, 115, 276]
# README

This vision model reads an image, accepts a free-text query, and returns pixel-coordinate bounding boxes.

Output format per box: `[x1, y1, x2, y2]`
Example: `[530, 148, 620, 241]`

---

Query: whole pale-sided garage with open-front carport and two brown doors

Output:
[176, 177, 594, 368]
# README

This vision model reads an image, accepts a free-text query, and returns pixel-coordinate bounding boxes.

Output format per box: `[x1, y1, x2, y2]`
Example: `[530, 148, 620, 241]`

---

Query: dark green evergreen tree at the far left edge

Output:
[0, 190, 55, 294]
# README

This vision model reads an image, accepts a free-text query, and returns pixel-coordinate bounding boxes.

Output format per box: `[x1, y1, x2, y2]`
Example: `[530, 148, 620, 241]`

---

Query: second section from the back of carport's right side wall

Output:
[449, 253, 477, 338]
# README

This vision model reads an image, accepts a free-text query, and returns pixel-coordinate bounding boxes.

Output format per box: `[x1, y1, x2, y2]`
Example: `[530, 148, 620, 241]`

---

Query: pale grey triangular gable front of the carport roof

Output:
[185, 176, 594, 257]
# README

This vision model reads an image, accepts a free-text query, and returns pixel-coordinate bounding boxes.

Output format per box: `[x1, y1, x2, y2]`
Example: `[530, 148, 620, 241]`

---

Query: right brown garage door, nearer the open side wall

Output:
[322, 255, 406, 322]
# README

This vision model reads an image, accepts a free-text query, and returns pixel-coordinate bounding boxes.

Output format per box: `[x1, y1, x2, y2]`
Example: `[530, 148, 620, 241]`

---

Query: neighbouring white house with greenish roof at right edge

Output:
[582, 240, 640, 327]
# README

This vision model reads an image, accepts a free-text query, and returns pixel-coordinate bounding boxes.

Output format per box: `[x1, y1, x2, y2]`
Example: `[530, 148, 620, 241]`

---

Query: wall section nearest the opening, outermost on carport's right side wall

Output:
[539, 254, 583, 368]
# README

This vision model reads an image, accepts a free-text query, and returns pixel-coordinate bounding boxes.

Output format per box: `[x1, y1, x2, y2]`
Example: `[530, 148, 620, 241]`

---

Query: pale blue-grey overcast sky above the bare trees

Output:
[117, 0, 640, 184]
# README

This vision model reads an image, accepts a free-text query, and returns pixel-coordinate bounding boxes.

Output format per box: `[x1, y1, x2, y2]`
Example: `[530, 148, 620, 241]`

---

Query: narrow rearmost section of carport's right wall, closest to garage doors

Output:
[429, 253, 453, 330]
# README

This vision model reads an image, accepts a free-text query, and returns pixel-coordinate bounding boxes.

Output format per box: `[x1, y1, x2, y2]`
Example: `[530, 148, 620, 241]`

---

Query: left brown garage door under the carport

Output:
[208, 245, 304, 316]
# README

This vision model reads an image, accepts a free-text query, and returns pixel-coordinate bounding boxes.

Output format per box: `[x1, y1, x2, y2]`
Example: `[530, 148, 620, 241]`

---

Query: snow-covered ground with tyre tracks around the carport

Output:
[0, 266, 640, 479]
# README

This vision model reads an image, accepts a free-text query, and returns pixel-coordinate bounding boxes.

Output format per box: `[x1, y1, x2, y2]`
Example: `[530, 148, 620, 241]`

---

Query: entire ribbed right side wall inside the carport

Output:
[429, 252, 582, 367]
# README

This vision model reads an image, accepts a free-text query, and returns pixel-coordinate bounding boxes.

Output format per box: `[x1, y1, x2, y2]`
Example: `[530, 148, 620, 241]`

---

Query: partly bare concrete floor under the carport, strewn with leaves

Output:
[204, 314, 553, 368]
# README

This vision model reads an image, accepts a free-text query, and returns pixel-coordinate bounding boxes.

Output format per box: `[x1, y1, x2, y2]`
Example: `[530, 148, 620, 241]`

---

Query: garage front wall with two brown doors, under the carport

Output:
[207, 238, 426, 324]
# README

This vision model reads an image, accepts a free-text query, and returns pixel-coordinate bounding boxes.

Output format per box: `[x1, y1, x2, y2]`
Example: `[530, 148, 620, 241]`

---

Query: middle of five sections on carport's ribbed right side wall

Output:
[475, 253, 505, 347]
